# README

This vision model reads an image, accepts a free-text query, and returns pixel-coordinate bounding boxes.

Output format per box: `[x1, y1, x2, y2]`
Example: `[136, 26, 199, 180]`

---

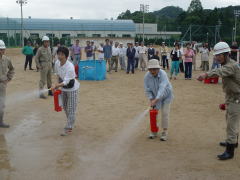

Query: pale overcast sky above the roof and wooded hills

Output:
[0, 0, 240, 19]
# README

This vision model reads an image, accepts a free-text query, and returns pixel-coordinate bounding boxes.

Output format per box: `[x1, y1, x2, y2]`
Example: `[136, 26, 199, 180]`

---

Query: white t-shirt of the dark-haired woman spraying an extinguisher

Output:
[55, 60, 80, 91]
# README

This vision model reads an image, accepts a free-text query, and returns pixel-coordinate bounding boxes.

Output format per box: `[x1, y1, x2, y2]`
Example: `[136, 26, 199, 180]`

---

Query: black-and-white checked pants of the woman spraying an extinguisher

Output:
[62, 90, 78, 129]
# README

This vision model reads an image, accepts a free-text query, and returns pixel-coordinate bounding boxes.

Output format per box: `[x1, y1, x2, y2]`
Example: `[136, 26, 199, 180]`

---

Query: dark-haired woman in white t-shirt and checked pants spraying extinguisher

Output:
[51, 46, 80, 136]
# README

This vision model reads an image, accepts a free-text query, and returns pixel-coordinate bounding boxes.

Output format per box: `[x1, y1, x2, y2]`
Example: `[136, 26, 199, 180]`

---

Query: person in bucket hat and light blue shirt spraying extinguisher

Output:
[144, 59, 173, 141]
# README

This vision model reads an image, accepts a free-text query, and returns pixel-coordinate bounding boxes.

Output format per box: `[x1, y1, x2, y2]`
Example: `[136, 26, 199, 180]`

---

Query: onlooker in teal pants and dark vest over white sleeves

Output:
[170, 43, 182, 80]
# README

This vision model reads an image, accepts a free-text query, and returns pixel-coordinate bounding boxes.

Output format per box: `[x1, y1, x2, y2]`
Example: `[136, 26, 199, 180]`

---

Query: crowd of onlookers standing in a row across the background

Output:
[22, 39, 239, 80]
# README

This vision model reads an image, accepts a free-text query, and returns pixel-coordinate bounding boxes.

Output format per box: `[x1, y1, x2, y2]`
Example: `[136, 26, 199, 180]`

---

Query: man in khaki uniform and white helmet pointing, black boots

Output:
[198, 42, 240, 160]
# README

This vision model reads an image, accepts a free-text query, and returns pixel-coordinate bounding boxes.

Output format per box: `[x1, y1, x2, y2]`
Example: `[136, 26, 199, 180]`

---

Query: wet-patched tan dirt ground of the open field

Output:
[0, 49, 240, 180]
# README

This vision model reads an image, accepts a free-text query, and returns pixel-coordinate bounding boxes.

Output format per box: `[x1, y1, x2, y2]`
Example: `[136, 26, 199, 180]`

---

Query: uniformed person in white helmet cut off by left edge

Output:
[0, 40, 14, 128]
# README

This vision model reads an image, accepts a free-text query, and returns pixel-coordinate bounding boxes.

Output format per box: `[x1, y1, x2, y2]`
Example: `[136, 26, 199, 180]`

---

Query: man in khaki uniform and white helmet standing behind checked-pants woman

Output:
[35, 36, 52, 99]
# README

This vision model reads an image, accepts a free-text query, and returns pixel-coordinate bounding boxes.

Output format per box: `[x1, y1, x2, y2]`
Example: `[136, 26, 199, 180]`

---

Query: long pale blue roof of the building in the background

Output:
[0, 18, 136, 32]
